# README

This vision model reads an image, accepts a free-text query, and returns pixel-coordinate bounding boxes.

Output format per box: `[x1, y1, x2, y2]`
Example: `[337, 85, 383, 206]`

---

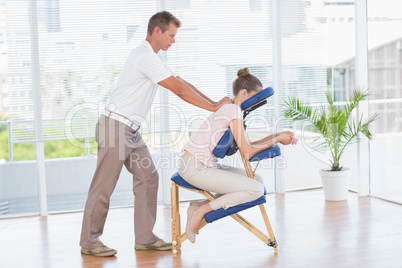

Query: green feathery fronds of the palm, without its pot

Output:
[283, 89, 377, 170]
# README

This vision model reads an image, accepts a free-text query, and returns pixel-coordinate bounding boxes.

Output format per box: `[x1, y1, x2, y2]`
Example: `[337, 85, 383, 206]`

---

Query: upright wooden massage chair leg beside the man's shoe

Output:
[170, 182, 181, 255]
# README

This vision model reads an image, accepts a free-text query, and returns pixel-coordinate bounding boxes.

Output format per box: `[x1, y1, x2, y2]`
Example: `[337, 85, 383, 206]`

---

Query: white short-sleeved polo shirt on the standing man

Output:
[106, 40, 173, 126]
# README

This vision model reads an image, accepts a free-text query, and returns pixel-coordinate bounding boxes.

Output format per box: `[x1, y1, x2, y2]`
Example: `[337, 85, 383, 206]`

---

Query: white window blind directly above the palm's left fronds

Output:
[279, 0, 327, 103]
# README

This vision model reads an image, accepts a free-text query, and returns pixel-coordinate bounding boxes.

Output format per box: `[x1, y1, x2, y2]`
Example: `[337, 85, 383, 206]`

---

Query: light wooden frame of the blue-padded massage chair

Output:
[171, 156, 278, 256]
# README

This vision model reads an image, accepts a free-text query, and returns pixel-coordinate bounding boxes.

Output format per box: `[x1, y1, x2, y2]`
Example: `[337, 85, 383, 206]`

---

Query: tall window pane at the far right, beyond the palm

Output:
[367, 0, 402, 203]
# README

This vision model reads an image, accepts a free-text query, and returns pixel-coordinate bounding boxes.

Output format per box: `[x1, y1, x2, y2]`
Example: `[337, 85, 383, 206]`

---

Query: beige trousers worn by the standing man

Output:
[80, 115, 159, 249]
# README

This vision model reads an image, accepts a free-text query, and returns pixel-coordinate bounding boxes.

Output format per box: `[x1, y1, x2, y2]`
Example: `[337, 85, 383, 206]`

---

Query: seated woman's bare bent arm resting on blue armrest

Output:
[229, 119, 297, 159]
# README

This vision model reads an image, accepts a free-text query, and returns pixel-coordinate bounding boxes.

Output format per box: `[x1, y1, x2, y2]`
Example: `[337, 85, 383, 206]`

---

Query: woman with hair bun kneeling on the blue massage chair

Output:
[179, 67, 298, 243]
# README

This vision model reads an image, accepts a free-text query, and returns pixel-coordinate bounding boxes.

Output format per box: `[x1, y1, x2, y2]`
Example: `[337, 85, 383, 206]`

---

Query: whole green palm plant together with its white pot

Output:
[284, 90, 377, 201]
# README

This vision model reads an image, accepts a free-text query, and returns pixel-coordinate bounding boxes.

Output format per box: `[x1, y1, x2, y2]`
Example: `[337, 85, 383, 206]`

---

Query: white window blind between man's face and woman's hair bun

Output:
[160, 1, 273, 136]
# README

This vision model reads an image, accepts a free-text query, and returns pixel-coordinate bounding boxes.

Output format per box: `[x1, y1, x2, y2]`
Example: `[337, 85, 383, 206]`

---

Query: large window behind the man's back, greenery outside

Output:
[0, 0, 159, 214]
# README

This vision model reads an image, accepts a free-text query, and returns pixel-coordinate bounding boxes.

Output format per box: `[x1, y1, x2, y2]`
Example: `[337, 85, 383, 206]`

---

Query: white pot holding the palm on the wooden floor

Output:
[320, 168, 351, 201]
